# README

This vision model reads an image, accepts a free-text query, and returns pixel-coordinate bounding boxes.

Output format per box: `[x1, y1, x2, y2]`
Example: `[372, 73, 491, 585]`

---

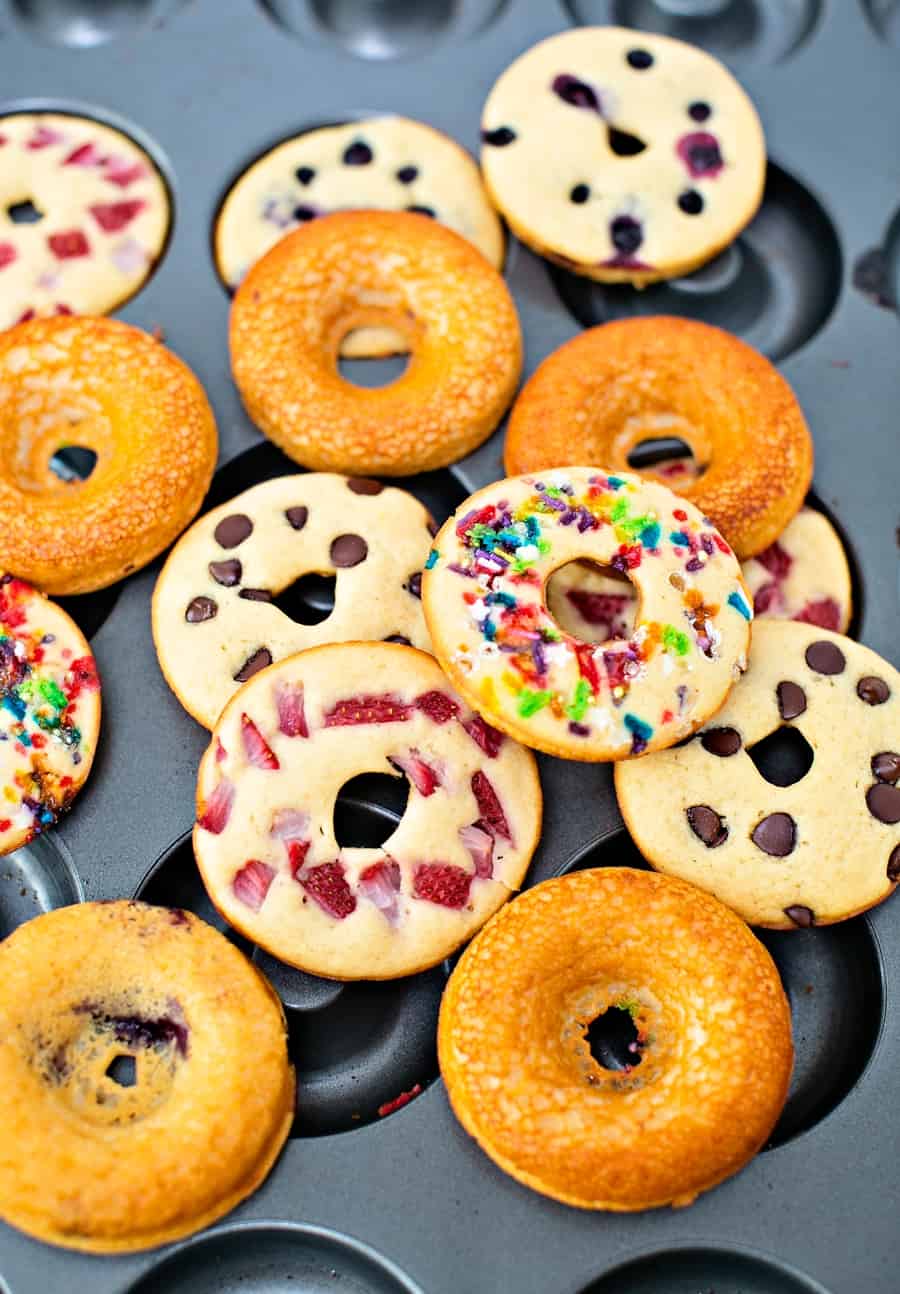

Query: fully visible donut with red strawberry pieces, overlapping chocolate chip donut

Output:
[194, 643, 541, 980]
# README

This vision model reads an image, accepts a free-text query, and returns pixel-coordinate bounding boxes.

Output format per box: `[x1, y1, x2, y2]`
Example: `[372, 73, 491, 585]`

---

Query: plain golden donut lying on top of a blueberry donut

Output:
[230, 211, 522, 476]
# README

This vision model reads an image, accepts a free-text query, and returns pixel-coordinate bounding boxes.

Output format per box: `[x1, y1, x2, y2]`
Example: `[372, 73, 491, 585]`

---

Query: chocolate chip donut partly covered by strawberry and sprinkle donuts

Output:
[153, 472, 436, 729]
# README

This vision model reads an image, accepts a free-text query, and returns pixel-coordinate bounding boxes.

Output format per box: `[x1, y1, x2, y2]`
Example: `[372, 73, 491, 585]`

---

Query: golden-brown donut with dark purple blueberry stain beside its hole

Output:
[0, 901, 295, 1254]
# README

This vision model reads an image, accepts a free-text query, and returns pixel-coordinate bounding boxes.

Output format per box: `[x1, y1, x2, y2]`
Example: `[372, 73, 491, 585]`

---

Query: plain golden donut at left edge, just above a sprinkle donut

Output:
[0, 318, 217, 594]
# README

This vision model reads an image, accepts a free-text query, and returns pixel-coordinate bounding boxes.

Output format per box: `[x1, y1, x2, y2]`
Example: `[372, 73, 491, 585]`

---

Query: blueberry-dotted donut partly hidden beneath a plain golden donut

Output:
[215, 116, 503, 358]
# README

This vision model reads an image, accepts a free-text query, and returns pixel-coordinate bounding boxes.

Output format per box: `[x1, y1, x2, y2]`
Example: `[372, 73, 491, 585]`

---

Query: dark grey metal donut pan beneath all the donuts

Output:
[0, 0, 900, 1294]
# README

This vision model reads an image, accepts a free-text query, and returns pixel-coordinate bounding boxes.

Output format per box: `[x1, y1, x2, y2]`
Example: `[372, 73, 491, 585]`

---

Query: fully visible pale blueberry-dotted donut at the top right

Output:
[481, 27, 766, 286]
